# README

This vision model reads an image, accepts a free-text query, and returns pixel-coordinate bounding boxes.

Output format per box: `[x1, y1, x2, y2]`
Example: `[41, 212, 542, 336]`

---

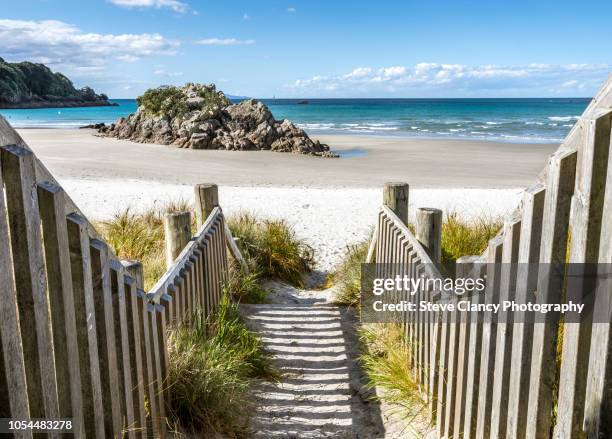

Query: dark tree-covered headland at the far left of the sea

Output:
[0, 58, 116, 108]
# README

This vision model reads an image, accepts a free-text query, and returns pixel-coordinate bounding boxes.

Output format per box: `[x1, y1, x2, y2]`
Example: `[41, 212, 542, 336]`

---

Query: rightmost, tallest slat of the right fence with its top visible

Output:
[555, 110, 612, 438]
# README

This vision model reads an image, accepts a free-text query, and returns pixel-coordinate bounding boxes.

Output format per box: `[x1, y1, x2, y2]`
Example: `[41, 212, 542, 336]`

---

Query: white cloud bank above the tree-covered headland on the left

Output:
[0, 20, 179, 67]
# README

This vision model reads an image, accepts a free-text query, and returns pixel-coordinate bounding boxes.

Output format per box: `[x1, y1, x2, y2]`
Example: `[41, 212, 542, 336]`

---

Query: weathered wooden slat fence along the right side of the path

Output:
[368, 74, 612, 439]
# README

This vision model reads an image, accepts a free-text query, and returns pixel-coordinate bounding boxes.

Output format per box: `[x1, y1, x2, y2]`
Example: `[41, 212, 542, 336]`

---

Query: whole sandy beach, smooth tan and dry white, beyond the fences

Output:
[19, 129, 557, 270]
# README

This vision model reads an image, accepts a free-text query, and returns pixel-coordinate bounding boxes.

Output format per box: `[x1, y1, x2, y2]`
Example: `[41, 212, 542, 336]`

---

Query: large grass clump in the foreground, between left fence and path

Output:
[167, 296, 277, 438]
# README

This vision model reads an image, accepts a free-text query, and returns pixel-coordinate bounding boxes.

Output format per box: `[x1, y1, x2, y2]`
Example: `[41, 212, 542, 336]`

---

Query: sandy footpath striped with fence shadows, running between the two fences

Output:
[241, 282, 388, 439]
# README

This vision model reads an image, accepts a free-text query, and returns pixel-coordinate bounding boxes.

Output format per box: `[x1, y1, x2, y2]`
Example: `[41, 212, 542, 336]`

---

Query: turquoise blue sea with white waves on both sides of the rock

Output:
[0, 98, 590, 143]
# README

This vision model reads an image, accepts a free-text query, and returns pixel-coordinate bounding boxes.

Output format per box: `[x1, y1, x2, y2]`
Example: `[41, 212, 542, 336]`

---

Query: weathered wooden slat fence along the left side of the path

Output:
[0, 117, 237, 439]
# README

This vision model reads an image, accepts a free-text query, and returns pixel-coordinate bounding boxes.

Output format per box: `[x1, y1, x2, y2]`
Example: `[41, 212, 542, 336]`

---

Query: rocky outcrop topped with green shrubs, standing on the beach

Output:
[98, 83, 337, 157]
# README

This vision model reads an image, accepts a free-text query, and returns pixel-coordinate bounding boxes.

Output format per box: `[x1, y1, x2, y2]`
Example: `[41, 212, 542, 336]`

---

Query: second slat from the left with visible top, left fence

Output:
[38, 182, 85, 436]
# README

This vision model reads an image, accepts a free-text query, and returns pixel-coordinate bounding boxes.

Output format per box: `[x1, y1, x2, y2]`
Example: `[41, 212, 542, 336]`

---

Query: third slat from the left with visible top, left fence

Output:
[66, 213, 106, 439]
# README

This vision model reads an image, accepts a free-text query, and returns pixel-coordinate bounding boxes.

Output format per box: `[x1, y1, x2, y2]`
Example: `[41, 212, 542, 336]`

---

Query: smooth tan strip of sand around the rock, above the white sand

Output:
[18, 129, 557, 188]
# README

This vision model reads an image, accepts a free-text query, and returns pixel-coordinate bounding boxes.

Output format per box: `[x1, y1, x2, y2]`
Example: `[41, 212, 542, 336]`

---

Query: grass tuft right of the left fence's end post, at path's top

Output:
[228, 213, 314, 287]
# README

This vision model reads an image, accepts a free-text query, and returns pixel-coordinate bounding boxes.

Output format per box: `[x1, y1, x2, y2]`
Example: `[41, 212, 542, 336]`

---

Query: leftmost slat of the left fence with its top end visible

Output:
[1, 145, 59, 419]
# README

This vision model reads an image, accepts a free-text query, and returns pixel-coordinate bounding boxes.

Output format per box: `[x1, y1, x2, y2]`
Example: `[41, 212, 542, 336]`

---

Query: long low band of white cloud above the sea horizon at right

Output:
[286, 62, 612, 96]
